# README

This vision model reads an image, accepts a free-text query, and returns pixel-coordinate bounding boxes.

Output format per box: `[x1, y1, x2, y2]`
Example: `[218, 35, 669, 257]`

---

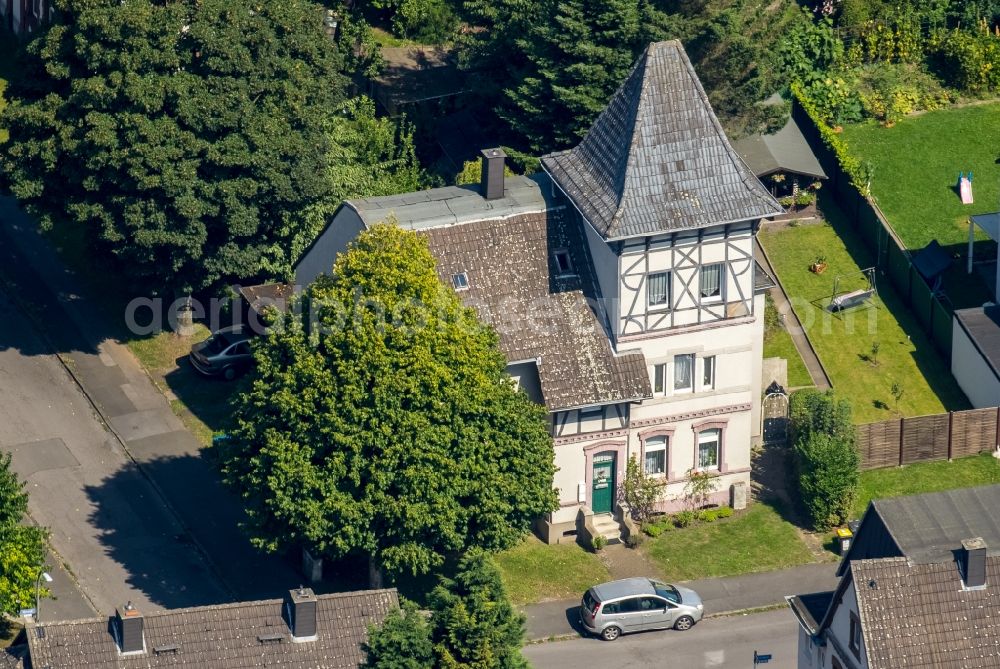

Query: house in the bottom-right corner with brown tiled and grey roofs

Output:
[787, 486, 1000, 669]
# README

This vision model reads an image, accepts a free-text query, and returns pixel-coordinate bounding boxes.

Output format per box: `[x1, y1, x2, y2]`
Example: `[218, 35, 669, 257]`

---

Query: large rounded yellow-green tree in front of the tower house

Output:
[223, 224, 556, 573]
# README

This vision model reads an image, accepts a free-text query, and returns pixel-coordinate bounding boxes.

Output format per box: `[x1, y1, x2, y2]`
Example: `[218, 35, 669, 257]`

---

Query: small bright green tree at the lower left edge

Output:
[0, 453, 48, 616]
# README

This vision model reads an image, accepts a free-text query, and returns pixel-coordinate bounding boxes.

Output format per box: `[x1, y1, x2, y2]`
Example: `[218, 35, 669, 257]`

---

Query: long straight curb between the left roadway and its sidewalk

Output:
[0, 237, 239, 609]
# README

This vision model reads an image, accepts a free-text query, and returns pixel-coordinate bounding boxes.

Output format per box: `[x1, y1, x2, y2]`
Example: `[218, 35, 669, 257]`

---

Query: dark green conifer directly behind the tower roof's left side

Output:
[500, 0, 662, 151]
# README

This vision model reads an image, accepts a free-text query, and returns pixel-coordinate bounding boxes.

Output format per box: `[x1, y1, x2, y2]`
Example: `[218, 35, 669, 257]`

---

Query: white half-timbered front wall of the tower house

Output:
[546, 223, 764, 541]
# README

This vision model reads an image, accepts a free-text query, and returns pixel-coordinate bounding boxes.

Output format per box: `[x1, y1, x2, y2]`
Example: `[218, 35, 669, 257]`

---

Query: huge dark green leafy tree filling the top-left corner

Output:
[0, 0, 344, 289]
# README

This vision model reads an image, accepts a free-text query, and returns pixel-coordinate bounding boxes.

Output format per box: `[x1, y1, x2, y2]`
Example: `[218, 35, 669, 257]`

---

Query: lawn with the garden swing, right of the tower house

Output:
[760, 201, 969, 423]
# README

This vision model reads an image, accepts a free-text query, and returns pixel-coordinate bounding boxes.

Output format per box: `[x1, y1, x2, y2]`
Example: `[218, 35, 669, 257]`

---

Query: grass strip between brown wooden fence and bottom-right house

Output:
[853, 453, 1000, 518]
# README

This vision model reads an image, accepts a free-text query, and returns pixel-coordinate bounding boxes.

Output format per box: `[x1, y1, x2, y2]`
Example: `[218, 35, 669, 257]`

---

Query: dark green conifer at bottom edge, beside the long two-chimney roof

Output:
[430, 550, 528, 669]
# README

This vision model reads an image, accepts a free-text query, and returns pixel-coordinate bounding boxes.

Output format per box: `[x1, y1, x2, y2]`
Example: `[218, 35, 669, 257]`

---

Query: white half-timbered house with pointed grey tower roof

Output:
[296, 42, 782, 542]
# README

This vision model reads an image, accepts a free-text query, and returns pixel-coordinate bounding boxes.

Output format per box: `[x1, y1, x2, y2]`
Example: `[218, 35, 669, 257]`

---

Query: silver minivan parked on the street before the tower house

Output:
[580, 578, 705, 641]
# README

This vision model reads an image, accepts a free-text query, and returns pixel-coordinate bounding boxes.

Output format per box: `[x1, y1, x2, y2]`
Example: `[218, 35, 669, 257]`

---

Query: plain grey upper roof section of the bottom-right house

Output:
[872, 485, 1000, 564]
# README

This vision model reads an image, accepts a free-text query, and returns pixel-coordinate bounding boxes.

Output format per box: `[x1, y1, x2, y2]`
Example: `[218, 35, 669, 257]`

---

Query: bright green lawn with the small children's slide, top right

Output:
[843, 103, 1000, 249]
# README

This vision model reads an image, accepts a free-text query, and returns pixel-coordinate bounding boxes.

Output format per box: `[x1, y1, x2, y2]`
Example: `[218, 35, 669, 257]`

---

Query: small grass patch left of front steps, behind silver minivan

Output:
[497, 535, 611, 605]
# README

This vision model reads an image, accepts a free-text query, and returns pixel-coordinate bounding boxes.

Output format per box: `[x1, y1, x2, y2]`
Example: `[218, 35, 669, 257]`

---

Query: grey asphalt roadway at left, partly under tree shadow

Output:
[0, 290, 228, 619]
